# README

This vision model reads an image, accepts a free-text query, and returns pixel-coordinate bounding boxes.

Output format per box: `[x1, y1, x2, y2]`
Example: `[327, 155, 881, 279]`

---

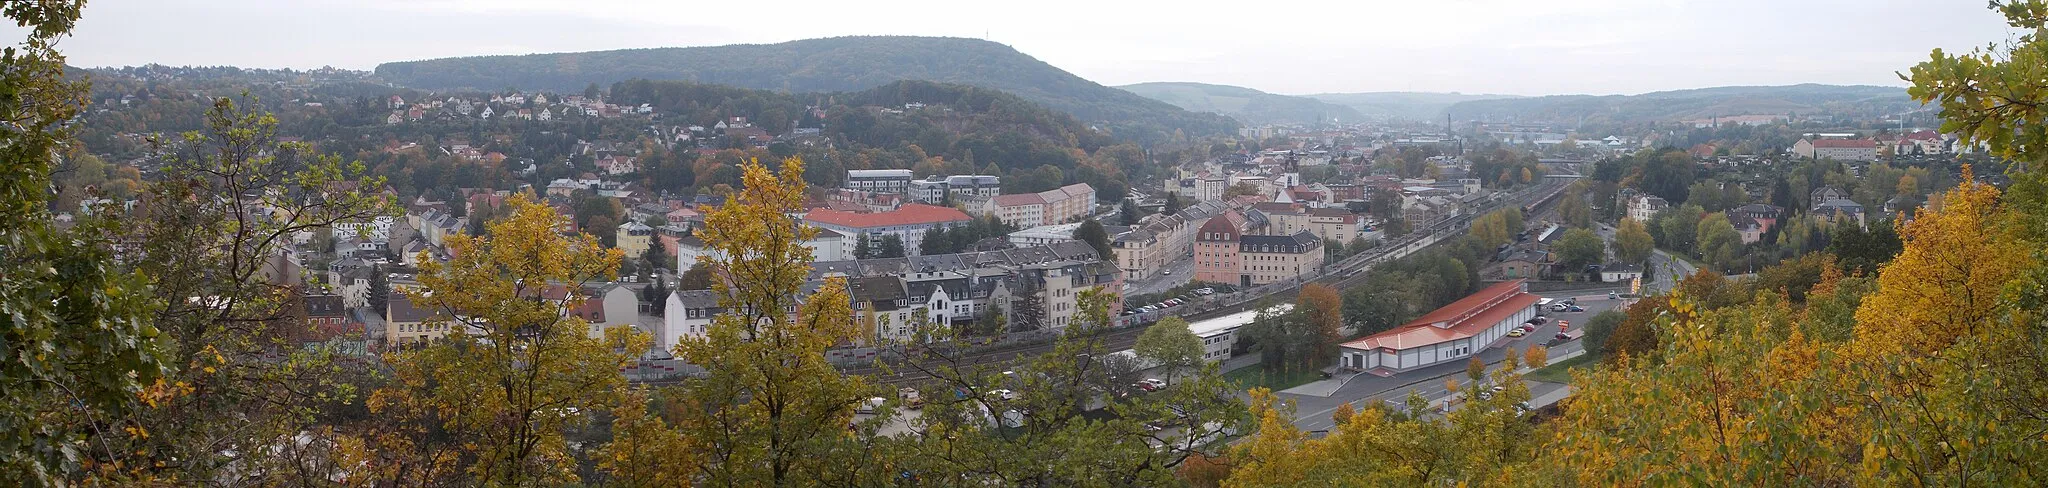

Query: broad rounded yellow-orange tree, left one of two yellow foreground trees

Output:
[369, 195, 649, 486]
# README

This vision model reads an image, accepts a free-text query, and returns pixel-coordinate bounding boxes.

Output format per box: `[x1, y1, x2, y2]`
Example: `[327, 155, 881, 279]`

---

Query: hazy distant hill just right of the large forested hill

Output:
[1116, 82, 1364, 125]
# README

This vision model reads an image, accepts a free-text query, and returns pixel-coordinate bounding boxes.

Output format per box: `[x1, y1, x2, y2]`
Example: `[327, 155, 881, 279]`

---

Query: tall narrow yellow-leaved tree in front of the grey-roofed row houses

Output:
[676, 158, 872, 486]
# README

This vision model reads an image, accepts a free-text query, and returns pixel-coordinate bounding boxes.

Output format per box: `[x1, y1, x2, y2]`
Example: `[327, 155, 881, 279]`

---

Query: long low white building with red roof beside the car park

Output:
[1337, 279, 1540, 375]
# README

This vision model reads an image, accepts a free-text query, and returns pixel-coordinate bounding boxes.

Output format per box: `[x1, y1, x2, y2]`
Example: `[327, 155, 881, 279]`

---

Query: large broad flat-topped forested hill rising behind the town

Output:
[377, 37, 1237, 141]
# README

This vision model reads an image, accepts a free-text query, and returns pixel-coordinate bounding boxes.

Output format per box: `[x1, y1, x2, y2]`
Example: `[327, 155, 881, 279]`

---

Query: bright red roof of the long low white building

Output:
[1343, 279, 1538, 351]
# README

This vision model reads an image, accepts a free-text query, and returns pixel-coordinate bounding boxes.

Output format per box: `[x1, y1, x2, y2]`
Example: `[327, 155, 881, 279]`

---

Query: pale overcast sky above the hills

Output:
[28, 0, 2013, 94]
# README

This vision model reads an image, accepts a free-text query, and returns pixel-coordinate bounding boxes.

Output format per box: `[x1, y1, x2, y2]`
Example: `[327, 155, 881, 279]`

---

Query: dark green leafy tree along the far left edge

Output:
[0, 2, 180, 479]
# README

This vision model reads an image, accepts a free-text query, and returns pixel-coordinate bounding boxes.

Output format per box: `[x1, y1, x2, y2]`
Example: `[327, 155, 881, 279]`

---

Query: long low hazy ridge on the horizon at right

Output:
[1450, 84, 1919, 123]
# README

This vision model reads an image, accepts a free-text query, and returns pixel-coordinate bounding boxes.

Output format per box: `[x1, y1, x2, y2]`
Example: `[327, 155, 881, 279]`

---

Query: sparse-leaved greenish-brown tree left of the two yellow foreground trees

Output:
[96, 98, 395, 484]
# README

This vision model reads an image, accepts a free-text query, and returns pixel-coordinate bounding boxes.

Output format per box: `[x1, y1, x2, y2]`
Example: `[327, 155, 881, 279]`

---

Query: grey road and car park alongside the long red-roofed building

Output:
[1280, 289, 1626, 431]
